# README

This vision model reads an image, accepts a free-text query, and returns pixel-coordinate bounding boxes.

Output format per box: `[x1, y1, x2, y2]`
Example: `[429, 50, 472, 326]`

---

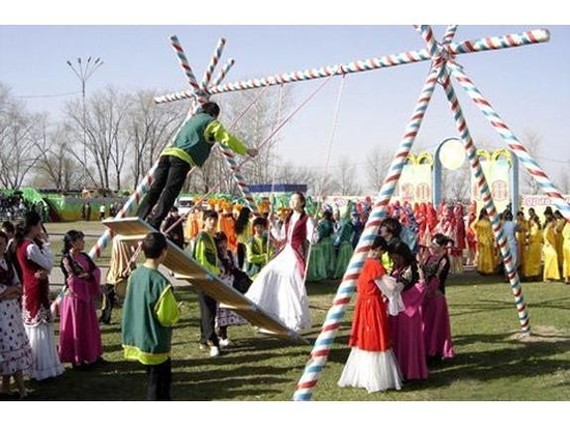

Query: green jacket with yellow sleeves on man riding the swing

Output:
[161, 113, 247, 166]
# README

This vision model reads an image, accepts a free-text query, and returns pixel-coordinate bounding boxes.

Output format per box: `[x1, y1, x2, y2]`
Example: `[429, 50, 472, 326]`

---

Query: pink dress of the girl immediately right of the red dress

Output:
[390, 267, 428, 380]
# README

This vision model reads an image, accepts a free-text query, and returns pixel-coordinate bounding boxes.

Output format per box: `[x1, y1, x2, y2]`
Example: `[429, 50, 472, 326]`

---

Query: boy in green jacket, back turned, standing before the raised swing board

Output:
[121, 232, 180, 400]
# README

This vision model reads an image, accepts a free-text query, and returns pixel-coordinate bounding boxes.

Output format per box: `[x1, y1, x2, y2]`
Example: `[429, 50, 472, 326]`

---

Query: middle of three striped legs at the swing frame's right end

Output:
[443, 69, 530, 334]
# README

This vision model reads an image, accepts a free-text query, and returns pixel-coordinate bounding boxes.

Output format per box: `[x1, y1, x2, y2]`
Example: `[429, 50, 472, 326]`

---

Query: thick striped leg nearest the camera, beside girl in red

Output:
[293, 63, 442, 400]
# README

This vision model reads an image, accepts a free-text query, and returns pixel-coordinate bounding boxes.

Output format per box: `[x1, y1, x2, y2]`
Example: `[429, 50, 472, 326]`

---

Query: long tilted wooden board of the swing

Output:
[103, 217, 309, 344]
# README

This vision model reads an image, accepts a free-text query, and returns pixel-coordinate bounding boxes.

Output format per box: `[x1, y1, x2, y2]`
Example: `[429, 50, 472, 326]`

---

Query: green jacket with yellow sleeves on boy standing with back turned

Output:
[121, 265, 180, 365]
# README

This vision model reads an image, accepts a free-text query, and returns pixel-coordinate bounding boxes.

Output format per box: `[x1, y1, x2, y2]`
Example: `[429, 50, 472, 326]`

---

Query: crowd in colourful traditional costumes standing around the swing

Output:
[0, 193, 570, 399]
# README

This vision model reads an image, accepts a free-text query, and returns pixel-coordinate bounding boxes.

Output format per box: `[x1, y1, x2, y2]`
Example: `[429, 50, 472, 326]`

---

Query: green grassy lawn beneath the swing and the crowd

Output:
[28, 223, 570, 401]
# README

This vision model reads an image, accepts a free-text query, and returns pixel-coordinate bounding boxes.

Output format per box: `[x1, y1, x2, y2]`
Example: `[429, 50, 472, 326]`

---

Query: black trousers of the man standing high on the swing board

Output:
[137, 156, 191, 230]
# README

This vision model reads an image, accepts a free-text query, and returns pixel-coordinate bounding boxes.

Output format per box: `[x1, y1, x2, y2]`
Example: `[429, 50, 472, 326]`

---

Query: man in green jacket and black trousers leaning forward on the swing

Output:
[137, 102, 257, 230]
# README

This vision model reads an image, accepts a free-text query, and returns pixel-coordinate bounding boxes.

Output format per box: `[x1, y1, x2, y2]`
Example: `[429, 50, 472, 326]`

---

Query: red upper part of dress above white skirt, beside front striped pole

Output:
[349, 258, 392, 351]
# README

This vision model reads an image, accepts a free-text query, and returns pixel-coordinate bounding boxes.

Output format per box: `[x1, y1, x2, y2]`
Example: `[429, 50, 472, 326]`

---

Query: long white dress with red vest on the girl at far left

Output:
[16, 239, 64, 380]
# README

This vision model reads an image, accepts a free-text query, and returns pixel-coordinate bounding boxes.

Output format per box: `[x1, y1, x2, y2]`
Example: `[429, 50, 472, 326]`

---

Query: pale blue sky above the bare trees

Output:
[0, 2, 570, 193]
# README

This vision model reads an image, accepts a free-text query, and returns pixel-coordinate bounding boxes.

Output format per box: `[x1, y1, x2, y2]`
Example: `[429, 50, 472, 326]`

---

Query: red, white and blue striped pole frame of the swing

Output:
[85, 25, 570, 400]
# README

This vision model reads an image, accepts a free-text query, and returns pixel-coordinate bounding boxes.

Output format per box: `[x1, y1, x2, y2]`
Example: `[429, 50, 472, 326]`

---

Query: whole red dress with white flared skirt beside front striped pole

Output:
[338, 257, 402, 393]
